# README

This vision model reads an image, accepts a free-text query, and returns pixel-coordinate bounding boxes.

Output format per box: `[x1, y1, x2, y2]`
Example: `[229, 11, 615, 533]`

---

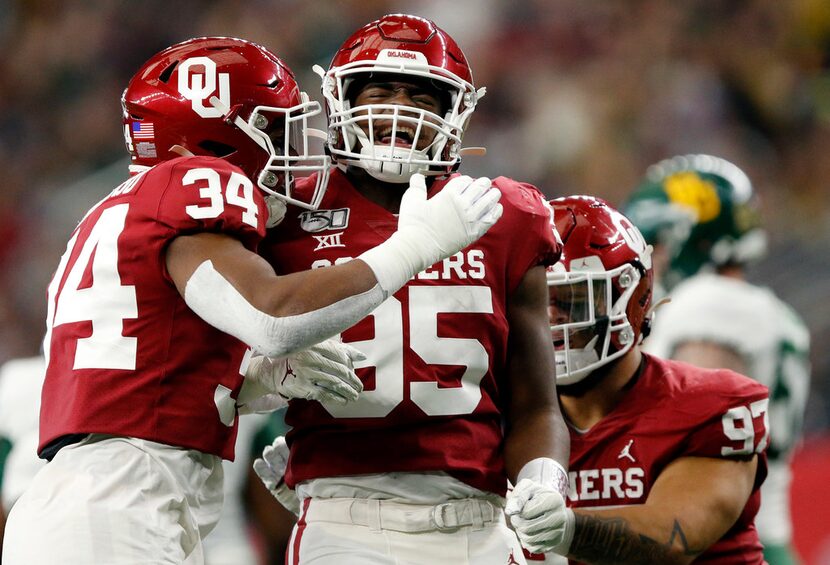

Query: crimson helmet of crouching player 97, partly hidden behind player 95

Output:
[547, 196, 653, 385]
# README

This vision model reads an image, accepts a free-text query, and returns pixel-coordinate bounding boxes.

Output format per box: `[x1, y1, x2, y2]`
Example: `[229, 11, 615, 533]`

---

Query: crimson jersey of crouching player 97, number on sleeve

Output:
[548, 353, 769, 565]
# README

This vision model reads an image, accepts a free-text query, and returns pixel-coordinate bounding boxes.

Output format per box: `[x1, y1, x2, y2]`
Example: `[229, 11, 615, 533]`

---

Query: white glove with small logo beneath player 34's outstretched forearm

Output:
[237, 339, 366, 414]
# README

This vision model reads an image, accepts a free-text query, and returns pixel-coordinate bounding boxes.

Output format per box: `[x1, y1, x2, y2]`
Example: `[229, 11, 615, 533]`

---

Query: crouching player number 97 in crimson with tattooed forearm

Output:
[528, 196, 769, 564]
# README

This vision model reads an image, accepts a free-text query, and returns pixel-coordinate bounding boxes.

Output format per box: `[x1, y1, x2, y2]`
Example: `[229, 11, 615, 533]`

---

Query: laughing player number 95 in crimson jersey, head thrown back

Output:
[255, 15, 568, 564]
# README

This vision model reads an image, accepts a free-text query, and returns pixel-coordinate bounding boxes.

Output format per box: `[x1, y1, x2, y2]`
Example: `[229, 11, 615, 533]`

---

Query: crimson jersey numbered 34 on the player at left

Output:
[38, 157, 267, 459]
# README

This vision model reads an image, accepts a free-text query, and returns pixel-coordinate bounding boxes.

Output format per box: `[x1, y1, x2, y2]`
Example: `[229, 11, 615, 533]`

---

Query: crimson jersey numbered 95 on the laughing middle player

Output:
[262, 170, 561, 494]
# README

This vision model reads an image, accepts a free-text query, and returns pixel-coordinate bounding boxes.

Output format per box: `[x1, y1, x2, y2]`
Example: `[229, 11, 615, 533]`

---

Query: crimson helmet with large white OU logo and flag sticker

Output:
[121, 37, 330, 209]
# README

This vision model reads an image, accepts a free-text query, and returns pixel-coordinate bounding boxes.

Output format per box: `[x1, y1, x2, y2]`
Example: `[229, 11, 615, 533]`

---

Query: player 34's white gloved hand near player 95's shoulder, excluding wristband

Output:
[398, 174, 503, 256]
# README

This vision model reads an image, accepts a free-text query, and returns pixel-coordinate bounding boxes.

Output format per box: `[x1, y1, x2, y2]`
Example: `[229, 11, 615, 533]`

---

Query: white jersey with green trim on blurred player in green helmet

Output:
[644, 273, 810, 545]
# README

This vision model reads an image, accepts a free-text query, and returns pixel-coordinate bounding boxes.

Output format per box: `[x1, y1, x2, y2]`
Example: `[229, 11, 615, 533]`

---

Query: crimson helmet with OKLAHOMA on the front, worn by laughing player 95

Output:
[315, 14, 484, 183]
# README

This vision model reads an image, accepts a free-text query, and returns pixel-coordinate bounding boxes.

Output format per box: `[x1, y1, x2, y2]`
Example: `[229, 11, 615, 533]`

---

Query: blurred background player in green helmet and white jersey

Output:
[625, 155, 810, 565]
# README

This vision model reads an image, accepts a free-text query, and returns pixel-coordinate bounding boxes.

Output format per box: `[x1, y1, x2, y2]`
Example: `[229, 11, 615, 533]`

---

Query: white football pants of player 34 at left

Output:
[3, 435, 223, 565]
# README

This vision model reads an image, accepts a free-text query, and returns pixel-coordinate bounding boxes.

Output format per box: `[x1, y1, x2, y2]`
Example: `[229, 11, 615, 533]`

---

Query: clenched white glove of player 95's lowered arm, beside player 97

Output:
[504, 479, 575, 555]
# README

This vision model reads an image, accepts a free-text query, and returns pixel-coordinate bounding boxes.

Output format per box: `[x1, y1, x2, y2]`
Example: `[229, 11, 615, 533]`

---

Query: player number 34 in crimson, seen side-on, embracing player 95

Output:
[3, 37, 501, 565]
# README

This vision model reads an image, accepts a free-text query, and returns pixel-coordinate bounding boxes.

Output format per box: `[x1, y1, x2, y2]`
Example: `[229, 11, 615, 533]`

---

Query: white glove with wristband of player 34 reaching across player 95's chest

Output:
[359, 174, 504, 294]
